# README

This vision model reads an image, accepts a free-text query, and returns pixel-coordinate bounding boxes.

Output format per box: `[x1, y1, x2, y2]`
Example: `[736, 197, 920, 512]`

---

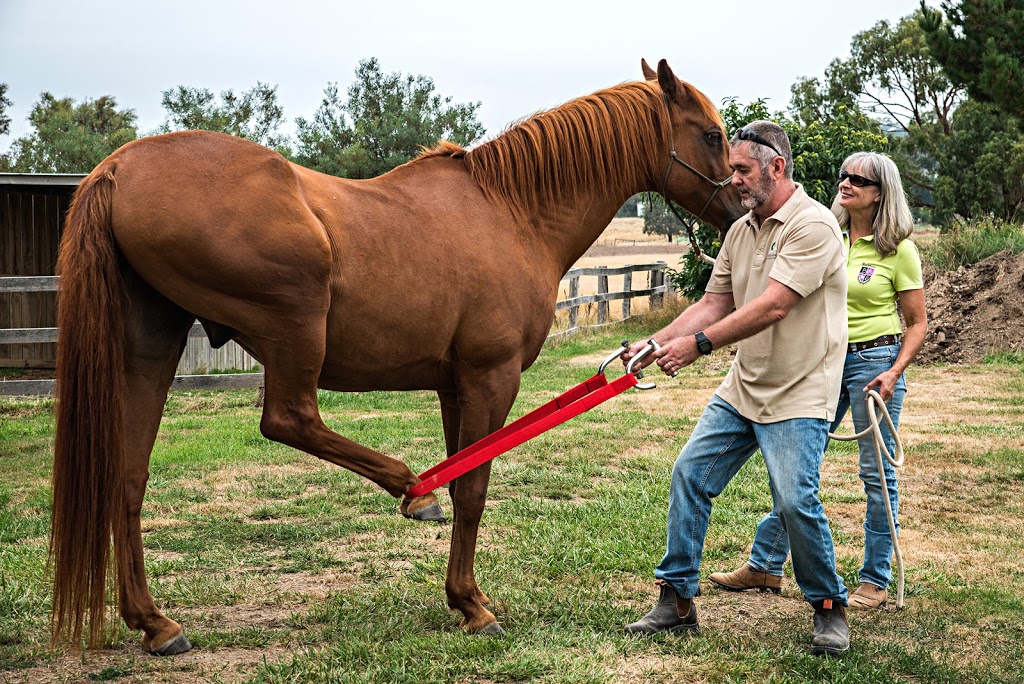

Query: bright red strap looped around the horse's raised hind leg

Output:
[406, 373, 637, 498]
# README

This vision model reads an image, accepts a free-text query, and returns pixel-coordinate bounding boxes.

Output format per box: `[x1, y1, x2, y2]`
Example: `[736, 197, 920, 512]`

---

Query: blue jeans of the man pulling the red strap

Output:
[654, 394, 847, 605]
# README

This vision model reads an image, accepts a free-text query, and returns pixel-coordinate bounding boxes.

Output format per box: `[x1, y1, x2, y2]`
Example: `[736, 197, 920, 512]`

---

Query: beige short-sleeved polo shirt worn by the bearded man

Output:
[707, 184, 847, 423]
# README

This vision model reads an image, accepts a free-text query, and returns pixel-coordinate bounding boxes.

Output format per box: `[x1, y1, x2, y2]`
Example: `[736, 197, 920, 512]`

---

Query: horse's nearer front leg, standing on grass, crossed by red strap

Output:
[444, 362, 521, 634]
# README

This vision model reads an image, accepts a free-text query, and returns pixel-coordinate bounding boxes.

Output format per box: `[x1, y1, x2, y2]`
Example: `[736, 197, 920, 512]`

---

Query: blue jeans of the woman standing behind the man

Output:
[750, 344, 906, 589]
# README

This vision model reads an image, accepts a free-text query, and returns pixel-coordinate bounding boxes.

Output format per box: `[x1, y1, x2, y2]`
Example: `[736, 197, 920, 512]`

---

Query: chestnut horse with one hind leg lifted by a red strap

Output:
[50, 60, 743, 654]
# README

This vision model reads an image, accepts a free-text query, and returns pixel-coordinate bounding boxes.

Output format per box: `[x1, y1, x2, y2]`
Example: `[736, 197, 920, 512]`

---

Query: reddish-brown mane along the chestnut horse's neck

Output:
[420, 81, 721, 216]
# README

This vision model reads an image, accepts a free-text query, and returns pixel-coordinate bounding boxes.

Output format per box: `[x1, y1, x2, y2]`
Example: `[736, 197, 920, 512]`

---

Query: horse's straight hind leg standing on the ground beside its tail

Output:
[115, 272, 193, 655]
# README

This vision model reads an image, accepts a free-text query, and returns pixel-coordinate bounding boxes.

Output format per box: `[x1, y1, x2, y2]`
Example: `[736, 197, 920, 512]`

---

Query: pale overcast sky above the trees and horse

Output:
[0, 0, 937, 151]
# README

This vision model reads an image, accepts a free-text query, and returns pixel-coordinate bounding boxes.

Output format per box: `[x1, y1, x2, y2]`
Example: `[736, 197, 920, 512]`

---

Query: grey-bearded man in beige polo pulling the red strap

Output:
[624, 121, 850, 654]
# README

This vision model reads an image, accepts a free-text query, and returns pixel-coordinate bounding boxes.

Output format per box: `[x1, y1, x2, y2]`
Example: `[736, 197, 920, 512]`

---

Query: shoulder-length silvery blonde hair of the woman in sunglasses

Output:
[831, 152, 913, 256]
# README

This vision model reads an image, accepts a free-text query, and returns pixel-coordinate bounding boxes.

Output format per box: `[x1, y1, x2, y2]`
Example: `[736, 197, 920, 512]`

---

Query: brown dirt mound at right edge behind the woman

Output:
[918, 250, 1024, 364]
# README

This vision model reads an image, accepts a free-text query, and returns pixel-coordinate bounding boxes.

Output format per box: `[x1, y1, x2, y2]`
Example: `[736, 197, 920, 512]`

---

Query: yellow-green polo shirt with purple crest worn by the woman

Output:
[843, 233, 925, 342]
